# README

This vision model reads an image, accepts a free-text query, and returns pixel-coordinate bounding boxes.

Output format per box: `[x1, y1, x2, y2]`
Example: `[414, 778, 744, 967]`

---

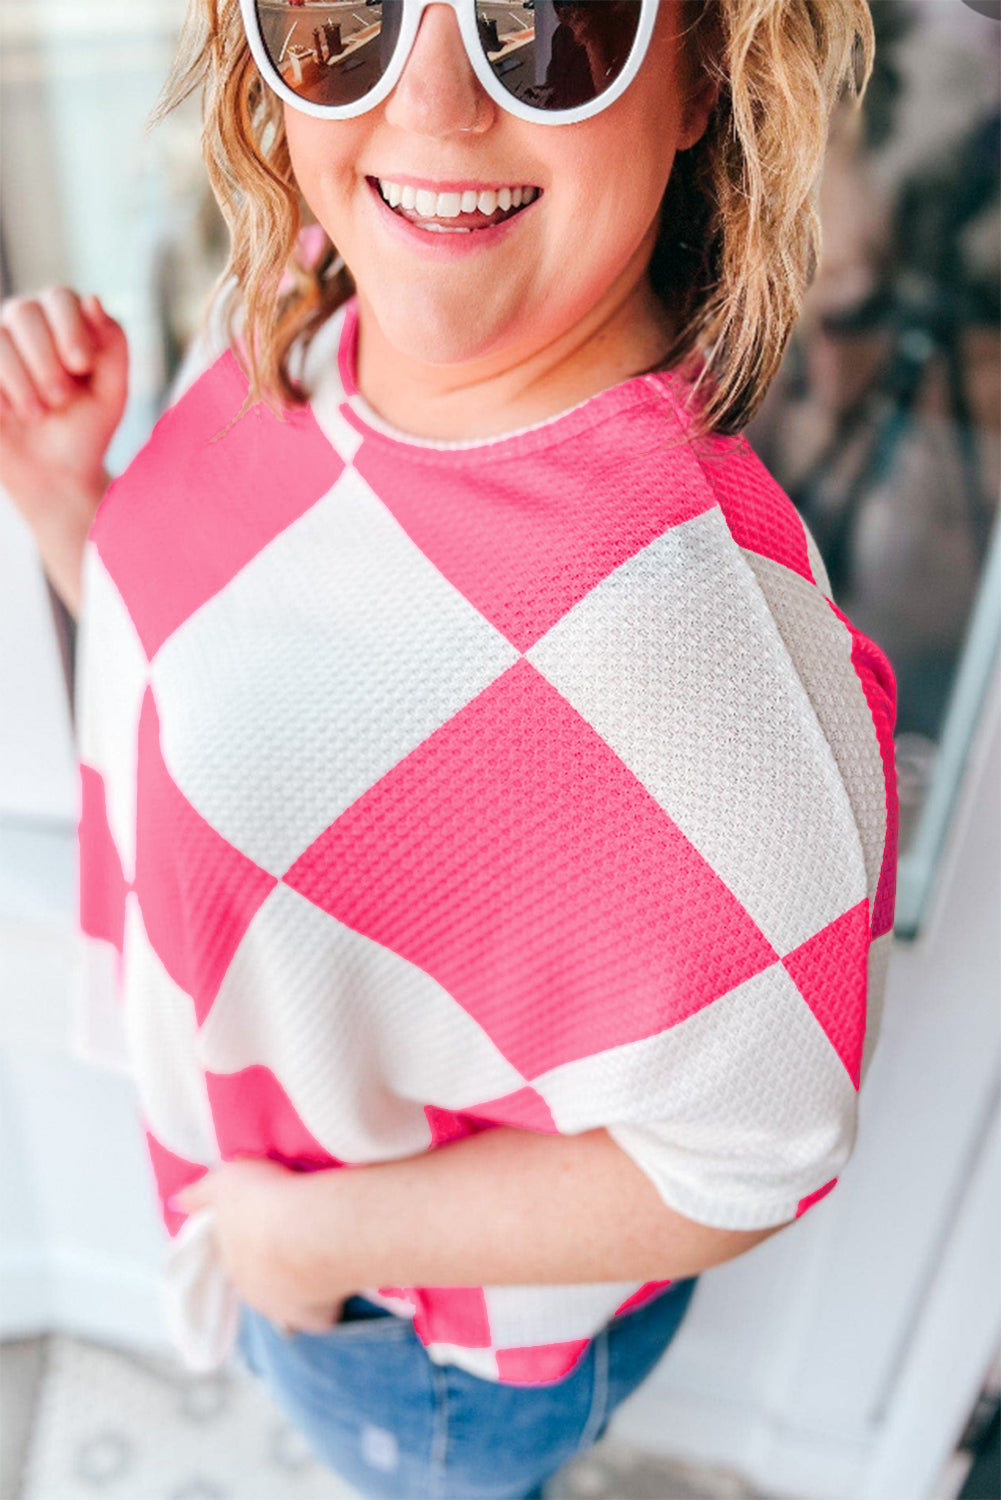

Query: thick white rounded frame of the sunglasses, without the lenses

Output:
[240, 0, 660, 125]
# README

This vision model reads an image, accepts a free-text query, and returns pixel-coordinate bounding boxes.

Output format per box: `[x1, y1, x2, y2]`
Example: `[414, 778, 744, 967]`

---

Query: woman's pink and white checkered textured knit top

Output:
[77, 289, 897, 1385]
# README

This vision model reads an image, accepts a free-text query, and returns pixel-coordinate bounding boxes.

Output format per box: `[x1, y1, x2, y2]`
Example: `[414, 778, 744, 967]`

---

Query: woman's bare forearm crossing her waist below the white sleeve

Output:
[296, 1127, 782, 1298]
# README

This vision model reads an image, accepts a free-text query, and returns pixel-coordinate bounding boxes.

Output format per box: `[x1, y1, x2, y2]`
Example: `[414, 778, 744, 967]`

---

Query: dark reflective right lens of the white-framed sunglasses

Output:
[476, 0, 642, 110]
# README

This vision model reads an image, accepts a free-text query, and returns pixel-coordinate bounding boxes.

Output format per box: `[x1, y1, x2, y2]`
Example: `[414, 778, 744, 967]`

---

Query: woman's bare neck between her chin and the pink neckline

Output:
[356, 237, 671, 441]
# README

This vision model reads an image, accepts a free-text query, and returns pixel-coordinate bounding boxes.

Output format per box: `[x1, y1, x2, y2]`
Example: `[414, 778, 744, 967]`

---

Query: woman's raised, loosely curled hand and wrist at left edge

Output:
[0, 287, 129, 533]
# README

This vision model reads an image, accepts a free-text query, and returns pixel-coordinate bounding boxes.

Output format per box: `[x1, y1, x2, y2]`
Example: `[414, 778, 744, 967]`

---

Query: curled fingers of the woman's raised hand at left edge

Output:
[0, 287, 98, 422]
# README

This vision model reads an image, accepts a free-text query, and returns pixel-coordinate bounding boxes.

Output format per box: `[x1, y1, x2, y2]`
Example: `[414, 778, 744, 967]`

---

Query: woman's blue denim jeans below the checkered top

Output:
[237, 1277, 698, 1500]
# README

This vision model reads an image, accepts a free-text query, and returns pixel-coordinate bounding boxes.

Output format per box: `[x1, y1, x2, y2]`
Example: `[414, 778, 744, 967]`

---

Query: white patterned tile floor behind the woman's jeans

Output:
[0, 1334, 768, 1500]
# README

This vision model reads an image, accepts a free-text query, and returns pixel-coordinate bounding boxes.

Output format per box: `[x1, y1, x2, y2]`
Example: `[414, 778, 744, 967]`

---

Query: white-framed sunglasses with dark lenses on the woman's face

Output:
[240, 0, 659, 125]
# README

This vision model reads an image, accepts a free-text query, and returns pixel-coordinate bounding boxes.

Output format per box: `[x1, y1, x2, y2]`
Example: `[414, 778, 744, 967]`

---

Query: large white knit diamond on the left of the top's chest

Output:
[152, 468, 518, 875]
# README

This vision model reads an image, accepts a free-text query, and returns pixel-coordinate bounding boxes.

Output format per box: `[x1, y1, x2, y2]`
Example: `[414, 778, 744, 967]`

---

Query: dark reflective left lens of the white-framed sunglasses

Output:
[255, 0, 404, 105]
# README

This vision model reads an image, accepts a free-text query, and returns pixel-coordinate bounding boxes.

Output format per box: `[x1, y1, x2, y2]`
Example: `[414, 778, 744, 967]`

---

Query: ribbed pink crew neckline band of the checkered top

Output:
[333, 294, 677, 462]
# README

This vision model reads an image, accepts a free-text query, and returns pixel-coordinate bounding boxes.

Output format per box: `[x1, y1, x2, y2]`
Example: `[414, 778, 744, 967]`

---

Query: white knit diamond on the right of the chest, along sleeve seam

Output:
[525, 509, 866, 954]
